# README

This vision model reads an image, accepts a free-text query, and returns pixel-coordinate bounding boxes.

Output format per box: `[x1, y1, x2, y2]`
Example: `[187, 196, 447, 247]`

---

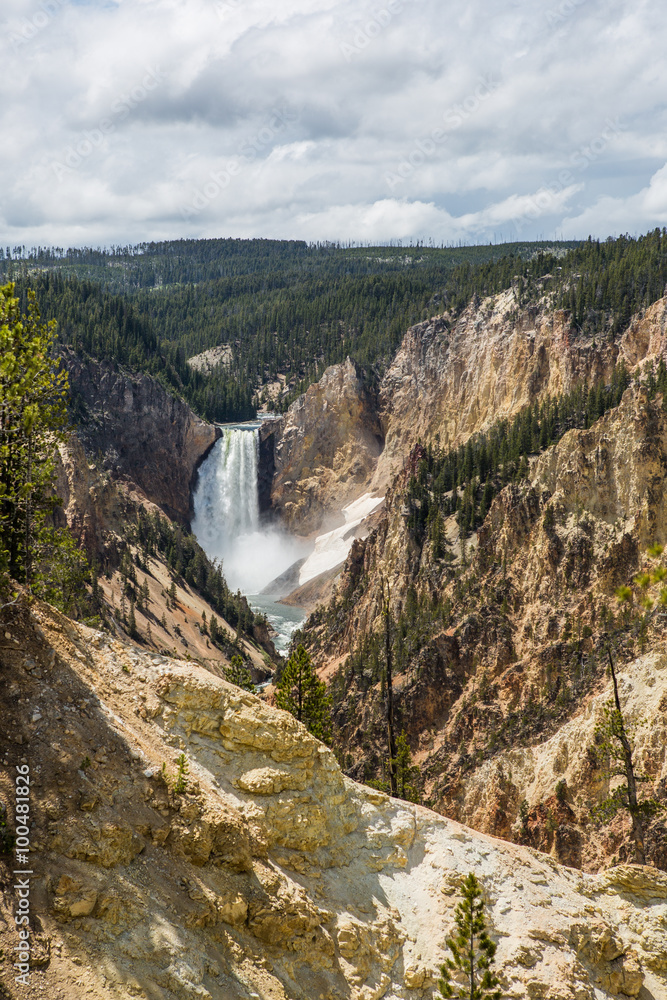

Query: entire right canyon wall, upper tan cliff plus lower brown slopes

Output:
[264, 291, 667, 871]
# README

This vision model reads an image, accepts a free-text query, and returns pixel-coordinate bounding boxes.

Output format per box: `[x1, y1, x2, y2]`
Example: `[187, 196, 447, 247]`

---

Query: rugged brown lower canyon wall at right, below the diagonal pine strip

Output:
[308, 388, 667, 870]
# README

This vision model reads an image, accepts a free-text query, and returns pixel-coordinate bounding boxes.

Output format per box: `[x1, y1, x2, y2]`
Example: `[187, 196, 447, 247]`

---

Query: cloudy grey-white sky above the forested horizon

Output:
[0, 0, 667, 247]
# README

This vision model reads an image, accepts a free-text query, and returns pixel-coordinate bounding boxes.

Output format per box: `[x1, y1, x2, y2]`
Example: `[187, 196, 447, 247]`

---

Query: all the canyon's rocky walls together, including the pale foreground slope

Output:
[0, 276, 667, 1000]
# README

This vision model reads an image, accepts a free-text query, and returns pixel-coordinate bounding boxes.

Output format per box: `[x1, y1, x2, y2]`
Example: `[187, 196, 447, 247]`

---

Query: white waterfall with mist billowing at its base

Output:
[192, 425, 310, 594]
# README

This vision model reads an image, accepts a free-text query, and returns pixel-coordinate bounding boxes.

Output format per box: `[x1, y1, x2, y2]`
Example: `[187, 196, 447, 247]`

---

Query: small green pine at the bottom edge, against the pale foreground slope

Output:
[438, 872, 502, 1000]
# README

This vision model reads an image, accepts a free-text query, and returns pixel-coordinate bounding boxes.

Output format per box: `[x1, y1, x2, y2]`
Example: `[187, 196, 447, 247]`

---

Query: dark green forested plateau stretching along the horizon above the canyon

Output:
[5, 229, 667, 421]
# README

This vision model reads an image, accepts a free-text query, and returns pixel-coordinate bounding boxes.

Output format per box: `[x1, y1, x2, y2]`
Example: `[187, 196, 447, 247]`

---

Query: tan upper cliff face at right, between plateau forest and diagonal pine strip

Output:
[374, 289, 667, 486]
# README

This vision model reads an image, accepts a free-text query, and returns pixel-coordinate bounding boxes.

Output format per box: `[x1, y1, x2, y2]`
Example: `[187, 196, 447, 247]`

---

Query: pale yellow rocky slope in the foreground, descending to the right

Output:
[0, 592, 667, 1000]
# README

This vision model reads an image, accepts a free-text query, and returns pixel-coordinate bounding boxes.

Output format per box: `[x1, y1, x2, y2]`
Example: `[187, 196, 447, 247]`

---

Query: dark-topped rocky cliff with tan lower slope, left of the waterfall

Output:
[55, 352, 277, 681]
